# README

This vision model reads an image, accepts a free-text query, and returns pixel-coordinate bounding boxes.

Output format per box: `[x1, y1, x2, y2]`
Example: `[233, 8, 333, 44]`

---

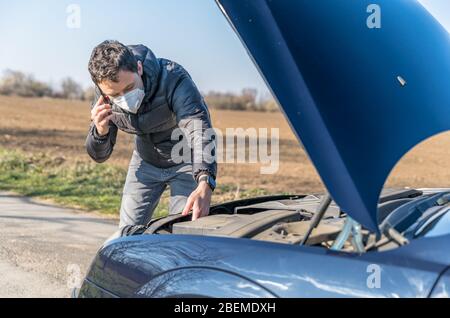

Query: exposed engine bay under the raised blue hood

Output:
[136, 189, 450, 253]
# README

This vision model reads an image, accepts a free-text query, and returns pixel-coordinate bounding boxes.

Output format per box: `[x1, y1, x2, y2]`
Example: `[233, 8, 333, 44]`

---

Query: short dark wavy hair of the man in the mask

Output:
[88, 40, 137, 84]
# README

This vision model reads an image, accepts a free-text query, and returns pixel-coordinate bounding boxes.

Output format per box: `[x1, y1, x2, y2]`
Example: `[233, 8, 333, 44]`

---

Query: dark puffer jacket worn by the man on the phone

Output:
[86, 45, 217, 178]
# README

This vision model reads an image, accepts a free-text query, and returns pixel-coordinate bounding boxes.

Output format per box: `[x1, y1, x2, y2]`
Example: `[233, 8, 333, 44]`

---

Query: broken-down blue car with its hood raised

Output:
[76, 0, 450, 298]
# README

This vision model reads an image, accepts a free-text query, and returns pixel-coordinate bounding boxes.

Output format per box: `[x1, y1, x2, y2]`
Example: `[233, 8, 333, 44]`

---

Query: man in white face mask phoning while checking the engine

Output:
[86, 41, 217, 228]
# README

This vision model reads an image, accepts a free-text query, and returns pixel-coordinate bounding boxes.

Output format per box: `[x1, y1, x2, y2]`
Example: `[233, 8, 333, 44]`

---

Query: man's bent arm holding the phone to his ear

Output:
[85, 94, 117, 163]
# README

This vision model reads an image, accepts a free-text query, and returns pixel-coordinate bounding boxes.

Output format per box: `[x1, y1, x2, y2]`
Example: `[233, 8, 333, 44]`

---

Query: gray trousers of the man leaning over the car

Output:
[119, 151, 197, 227]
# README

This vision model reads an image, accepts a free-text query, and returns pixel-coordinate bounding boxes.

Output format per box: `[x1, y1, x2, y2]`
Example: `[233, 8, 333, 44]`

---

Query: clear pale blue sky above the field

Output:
[0, 0, 450, 94]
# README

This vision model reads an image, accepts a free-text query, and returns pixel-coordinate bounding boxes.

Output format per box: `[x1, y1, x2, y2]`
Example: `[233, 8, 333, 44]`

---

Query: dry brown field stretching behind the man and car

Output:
[0, 96, 450, 199]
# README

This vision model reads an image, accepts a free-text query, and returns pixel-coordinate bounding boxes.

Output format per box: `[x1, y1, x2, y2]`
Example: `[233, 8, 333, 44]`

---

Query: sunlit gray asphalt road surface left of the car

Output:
[0, 192, 117, 297]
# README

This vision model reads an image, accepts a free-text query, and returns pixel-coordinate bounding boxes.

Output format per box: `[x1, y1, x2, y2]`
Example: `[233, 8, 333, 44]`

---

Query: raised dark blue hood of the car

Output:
[216, 0, 450, 231]
